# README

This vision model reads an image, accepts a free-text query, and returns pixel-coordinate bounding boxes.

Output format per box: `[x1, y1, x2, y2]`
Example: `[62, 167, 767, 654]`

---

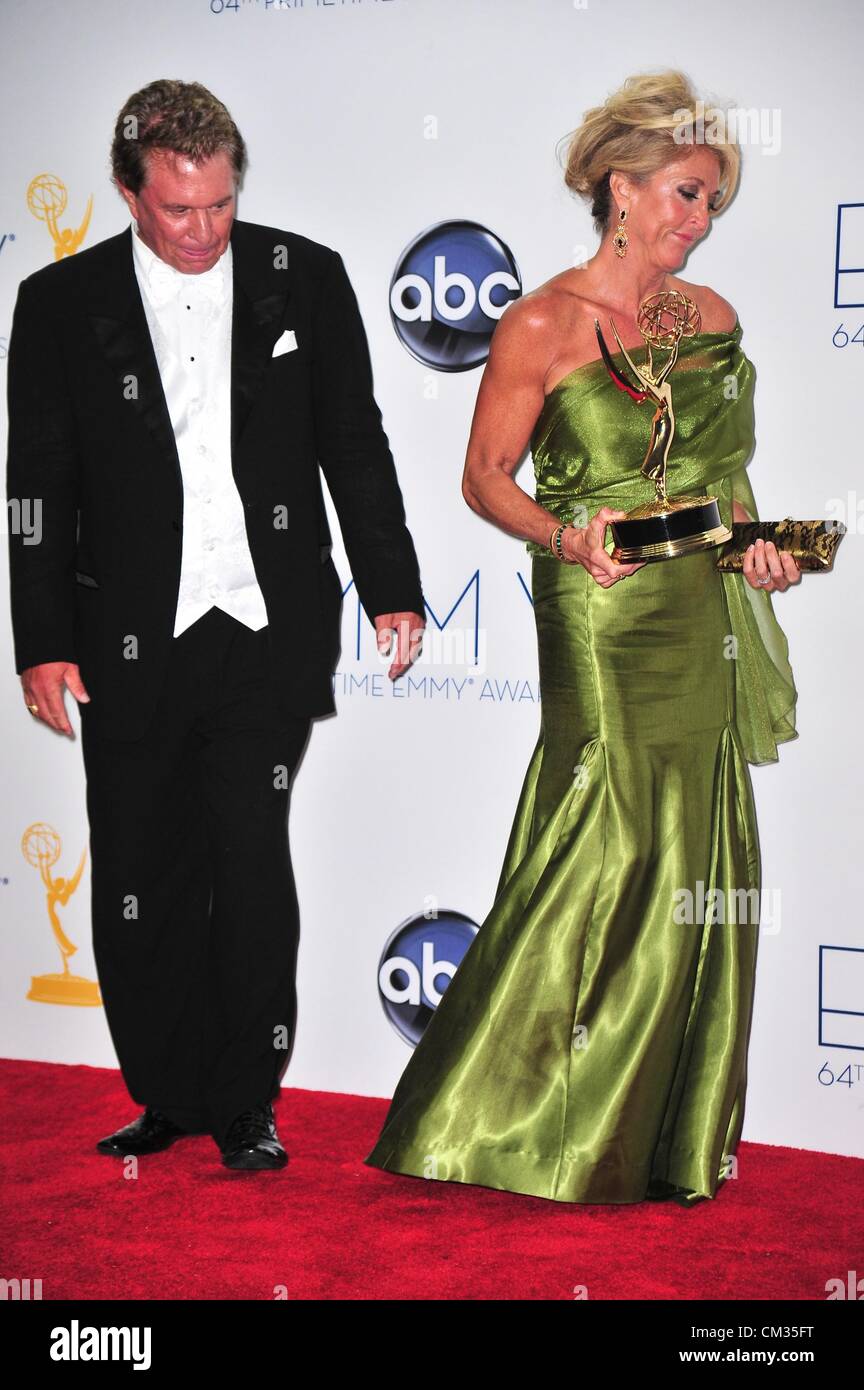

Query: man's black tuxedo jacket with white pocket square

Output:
[7, 220, 424, 738]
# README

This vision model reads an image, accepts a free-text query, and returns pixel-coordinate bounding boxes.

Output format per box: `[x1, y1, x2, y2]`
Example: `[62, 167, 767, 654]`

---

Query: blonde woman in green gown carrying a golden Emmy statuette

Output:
[367, 72, 800, 1205]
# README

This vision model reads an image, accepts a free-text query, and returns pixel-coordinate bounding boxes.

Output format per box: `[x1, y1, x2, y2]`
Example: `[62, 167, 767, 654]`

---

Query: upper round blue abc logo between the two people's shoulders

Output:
[390, 222, 522, 371]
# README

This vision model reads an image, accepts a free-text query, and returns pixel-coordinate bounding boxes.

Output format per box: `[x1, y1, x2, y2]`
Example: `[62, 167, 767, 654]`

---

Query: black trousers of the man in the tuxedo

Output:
[79, 607, 311, 1141]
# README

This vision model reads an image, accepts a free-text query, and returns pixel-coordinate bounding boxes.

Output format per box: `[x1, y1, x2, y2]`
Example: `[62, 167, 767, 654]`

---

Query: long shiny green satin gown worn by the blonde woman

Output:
[365, 322, 797, 1205]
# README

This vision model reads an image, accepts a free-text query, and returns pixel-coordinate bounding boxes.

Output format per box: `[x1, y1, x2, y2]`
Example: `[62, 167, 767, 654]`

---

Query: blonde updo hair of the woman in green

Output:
[564, 71, 740, 236]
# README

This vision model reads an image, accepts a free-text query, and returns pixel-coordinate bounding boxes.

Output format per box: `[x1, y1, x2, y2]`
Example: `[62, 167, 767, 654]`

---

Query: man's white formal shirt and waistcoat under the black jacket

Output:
[132, 221, 267, 637]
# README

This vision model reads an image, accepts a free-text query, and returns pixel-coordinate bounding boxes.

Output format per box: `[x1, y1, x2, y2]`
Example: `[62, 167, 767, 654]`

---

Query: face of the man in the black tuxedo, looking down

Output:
[121, 150, 236, 275]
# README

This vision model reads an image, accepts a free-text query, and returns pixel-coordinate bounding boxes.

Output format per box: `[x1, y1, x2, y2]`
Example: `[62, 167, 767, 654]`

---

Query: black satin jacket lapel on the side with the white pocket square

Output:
[231, 220, 290, 471]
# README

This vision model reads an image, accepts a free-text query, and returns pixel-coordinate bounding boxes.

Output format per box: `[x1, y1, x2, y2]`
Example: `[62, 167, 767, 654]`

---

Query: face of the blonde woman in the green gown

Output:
[613, 145, 720, 271]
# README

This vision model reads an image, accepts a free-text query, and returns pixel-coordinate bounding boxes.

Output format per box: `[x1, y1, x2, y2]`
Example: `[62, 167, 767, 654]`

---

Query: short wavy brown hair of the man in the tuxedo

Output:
[111, 78, 246, 193]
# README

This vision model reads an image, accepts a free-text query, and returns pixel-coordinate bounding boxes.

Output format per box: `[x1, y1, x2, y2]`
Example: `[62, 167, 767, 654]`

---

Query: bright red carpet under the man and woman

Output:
[0, 1061, 864, 1301]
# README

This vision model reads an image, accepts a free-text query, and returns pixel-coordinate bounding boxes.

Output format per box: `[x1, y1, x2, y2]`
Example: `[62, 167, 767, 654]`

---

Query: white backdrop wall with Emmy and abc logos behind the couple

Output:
[0, 0, 864, 1155]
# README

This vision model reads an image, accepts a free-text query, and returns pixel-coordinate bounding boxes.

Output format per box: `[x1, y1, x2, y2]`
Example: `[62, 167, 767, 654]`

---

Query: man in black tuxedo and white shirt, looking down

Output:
[7, 81, 424, 1169]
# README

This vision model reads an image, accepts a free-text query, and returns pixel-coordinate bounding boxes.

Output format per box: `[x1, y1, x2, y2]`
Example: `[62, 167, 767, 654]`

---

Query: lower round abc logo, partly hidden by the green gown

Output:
[378, 908, 478, 1047]
